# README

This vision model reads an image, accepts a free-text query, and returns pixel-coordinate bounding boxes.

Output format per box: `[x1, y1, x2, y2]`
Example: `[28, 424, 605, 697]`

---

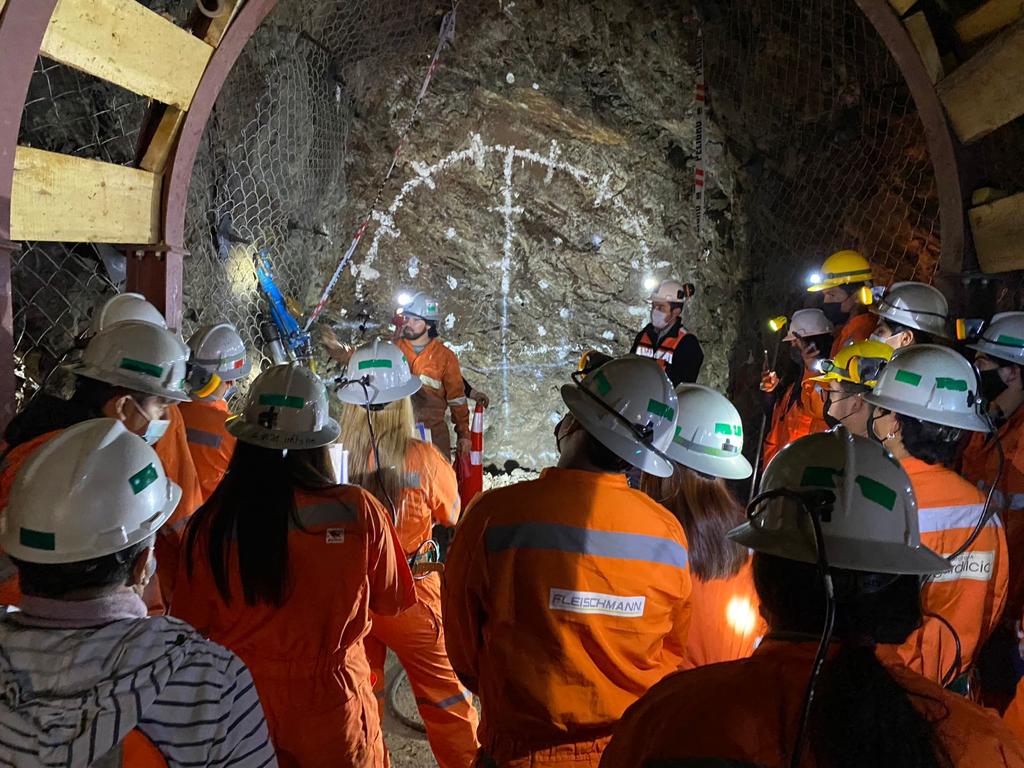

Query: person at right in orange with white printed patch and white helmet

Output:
[864, 344, 1009, 685]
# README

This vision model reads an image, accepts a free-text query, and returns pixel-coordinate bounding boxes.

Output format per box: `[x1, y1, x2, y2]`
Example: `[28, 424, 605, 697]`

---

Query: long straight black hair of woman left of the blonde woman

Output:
[185, 441, 334, 605]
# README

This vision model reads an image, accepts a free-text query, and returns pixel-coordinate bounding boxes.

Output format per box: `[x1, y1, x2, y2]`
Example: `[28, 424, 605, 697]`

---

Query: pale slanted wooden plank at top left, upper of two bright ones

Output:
[40, 0, 213, 110]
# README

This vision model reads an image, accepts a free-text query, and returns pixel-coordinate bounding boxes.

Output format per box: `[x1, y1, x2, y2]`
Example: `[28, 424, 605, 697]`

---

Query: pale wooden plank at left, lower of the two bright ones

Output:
[10, 146, 160, 244]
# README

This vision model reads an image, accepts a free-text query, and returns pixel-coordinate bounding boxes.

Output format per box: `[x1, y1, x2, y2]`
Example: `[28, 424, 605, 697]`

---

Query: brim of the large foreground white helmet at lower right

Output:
[726, 522, 951, 575]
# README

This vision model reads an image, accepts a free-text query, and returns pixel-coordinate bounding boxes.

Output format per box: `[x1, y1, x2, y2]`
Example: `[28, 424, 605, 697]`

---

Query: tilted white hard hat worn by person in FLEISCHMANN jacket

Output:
[561, 354, 676, 477]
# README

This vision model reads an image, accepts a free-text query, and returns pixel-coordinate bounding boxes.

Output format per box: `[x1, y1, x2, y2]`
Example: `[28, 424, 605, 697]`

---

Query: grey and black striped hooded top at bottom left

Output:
[0, 596, 278, 768]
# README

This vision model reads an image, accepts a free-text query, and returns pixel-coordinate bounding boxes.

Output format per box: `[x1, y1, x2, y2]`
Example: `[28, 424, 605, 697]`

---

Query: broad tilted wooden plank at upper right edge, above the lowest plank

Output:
[937, 20, 1024, 142]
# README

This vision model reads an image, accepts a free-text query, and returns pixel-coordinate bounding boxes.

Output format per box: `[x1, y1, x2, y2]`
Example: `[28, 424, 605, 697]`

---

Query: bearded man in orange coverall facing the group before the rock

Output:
[395, 293, 472, 460]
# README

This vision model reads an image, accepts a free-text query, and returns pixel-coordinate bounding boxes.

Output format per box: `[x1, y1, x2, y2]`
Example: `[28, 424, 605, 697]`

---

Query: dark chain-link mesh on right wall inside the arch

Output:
[705, 0, 939, 294]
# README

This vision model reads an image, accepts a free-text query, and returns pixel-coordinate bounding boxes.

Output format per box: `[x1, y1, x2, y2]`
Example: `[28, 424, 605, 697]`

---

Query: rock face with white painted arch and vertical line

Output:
[330, 0, 745, 467]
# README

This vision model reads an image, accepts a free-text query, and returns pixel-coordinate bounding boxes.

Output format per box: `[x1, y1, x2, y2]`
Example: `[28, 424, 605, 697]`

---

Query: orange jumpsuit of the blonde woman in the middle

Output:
[366, 440, 479, 768]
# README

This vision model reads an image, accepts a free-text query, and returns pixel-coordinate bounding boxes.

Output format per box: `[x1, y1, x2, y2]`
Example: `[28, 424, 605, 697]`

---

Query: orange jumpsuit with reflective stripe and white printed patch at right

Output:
[899, 458, 1009, 682]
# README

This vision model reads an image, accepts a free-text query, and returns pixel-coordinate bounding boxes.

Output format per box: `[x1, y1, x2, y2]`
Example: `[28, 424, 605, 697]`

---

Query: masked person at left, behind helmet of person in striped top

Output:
[0, 321, 195, 612]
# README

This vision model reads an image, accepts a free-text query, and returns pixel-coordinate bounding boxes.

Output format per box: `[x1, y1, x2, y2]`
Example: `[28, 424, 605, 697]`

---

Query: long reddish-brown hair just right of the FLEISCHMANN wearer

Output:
[640, 465, 748, 582]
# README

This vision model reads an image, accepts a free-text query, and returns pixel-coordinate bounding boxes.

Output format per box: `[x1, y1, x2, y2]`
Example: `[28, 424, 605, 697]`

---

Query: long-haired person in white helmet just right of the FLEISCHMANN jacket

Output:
[640, 384, 764, 669]
